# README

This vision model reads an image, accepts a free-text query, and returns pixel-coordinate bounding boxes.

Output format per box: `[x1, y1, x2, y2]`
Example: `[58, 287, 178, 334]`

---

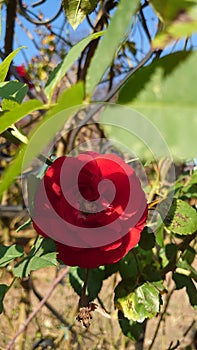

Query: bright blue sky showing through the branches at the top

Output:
[0, 0, 197, 65]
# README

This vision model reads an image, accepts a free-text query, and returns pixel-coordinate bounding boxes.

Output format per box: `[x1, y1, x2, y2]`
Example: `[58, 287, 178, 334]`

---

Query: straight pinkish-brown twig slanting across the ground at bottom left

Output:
[6, 267, 69, 350]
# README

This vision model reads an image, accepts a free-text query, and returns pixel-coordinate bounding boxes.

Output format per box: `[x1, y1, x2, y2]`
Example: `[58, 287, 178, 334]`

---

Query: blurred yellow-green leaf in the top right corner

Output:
[151, 0, 197, 49]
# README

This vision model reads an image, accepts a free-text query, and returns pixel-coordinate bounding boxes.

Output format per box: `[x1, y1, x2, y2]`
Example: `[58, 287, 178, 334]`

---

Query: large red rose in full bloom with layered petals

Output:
[33, 152, 148, 268]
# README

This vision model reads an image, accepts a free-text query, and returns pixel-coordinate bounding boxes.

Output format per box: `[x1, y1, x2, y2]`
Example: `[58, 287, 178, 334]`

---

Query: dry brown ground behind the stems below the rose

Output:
[0, 228, 197, 350]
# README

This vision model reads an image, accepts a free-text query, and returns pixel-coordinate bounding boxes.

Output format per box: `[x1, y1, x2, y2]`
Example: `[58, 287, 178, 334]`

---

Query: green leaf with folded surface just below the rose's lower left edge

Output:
[13, 238, 58, 278]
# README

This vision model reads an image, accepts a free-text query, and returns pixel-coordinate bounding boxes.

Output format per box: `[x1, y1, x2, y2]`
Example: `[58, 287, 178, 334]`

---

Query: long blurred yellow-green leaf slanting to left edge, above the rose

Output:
[0, 83, 84, 194]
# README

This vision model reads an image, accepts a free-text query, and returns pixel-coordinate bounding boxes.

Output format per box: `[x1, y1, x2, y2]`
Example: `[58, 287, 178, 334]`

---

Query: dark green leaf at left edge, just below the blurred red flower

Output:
[0, 81, 28, 103]
